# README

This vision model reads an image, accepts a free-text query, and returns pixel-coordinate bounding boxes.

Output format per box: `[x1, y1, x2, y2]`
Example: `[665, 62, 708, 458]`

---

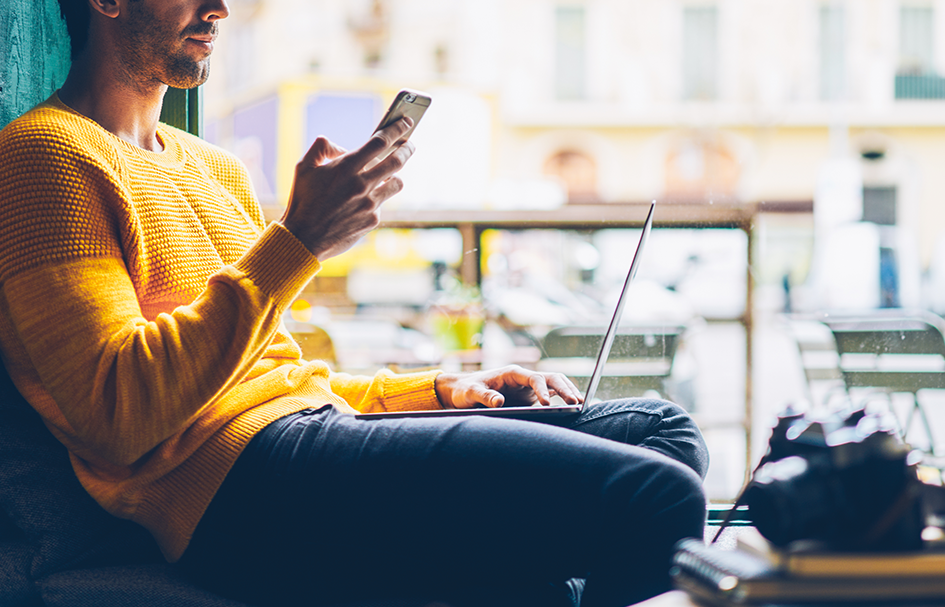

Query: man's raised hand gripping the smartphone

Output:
[282, 118, 414, 261]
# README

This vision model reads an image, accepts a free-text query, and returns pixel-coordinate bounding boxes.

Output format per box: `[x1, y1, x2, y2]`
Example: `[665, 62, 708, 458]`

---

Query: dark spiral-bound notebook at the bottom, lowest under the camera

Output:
[671, 539, 945, 605]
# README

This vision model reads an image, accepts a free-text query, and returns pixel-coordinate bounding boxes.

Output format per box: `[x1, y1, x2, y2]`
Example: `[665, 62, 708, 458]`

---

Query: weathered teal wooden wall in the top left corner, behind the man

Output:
[0, 0, 69, 127]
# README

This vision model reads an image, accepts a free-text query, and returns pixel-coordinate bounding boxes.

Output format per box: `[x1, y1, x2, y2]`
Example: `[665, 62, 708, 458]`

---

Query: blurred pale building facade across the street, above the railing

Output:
[207, 0, 945, 314]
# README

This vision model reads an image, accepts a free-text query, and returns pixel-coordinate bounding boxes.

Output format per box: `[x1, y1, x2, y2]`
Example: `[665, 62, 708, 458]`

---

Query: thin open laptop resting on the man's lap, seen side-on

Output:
[355, 202, 656, 419]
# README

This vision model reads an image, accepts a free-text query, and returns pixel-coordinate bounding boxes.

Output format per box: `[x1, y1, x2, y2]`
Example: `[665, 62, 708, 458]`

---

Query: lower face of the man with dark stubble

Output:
[121, 0, 227, 88]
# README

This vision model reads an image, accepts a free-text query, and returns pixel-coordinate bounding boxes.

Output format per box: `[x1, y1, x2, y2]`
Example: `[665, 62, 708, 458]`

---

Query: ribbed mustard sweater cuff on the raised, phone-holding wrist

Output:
[234, 222, 321, 307]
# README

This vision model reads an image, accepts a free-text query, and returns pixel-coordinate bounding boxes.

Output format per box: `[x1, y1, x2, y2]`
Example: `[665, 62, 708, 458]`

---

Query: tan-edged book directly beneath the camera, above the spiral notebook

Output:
[736, 528, 945, 577]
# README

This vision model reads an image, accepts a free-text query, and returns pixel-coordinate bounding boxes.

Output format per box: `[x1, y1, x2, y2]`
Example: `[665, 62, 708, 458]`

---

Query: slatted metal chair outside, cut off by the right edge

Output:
[820, 309, 945, 455]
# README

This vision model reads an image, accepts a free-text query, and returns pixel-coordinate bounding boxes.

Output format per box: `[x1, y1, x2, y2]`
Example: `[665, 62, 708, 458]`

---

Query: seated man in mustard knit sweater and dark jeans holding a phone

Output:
[0, 0, 707, 607]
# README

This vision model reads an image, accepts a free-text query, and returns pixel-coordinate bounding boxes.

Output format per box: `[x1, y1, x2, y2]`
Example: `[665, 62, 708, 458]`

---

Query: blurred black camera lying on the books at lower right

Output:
[740, 409, 945, 551]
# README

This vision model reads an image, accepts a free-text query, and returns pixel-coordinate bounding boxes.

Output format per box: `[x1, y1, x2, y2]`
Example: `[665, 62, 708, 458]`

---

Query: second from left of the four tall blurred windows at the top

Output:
[683, 6, 719, 101]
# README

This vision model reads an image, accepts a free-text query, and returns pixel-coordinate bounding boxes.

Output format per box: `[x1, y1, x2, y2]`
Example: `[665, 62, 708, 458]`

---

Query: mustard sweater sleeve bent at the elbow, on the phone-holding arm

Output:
[0, 121, 319, 466]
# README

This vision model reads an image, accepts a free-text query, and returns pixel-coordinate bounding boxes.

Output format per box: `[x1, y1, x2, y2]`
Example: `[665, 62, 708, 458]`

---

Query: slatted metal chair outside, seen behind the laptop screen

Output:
[536, 325, 684, 400]
